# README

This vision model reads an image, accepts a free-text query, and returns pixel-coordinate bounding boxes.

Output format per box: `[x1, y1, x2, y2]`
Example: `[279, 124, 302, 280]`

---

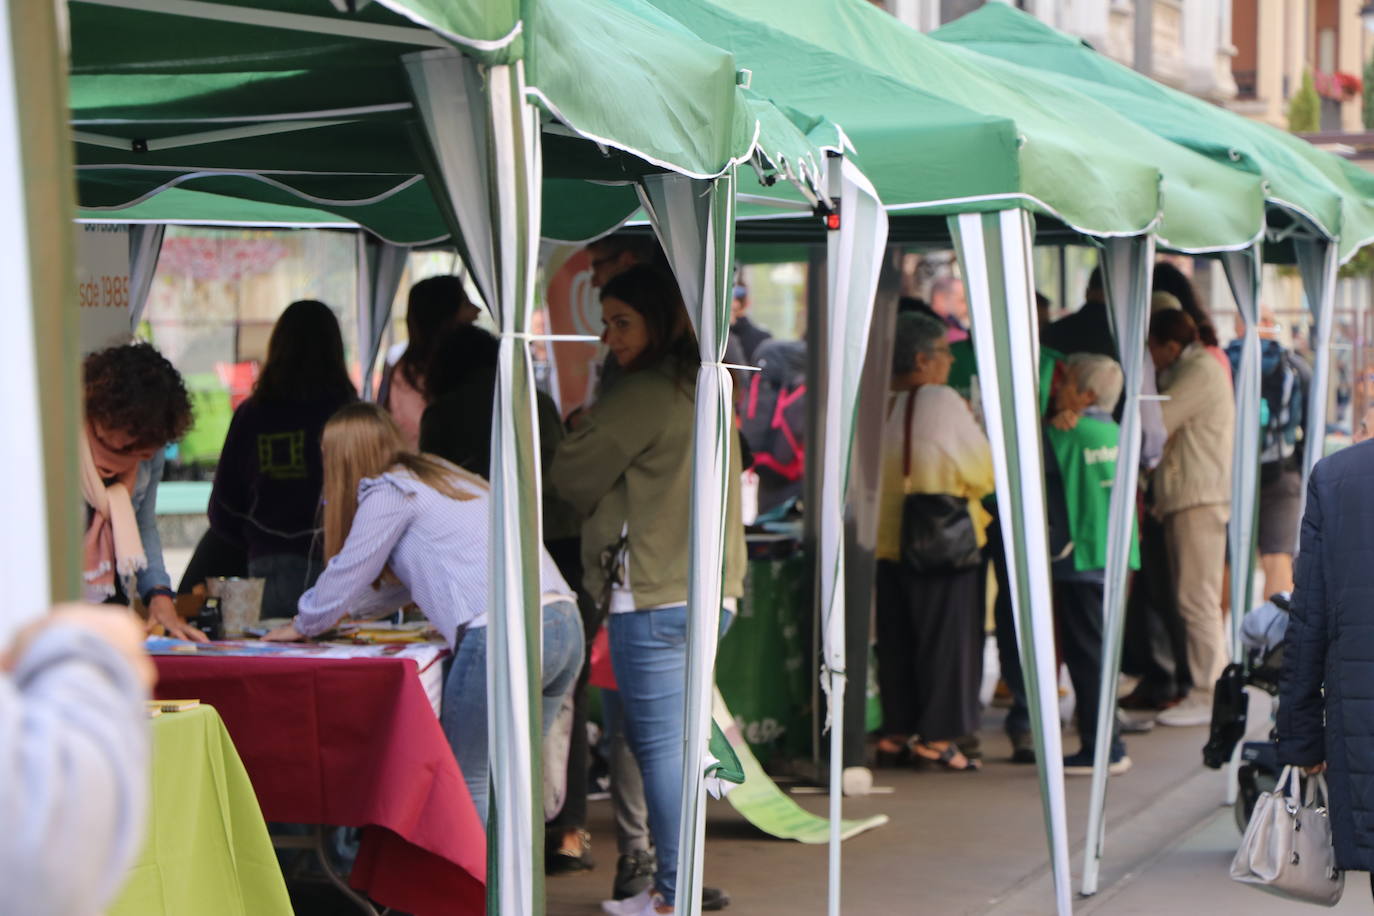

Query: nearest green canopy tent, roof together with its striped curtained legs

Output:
[71, 0, 871, 913]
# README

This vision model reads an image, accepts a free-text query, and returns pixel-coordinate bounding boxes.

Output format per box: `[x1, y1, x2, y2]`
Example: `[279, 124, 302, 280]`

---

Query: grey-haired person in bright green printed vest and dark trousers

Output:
[1044, 353, 1140, 776]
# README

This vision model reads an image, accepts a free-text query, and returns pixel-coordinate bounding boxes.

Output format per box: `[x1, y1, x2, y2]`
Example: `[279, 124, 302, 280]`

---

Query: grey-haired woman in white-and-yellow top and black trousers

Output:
[877, 313, 993, 770]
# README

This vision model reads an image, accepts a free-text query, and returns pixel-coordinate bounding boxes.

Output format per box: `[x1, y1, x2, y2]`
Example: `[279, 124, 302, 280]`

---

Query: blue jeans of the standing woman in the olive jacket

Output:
[610, 604, 732, 904]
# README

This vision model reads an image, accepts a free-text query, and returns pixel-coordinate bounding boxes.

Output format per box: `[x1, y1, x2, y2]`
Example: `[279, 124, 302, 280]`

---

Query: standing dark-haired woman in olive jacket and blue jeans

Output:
[550, 265, 745, 916]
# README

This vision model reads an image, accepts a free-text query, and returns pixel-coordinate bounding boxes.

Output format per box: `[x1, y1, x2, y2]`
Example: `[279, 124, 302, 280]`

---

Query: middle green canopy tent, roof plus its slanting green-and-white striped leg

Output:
[643, 0, 1263, 909]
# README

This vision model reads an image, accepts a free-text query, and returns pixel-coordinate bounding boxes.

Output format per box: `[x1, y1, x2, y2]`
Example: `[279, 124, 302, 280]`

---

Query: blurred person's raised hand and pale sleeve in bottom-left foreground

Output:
[0, 604, 155, 916]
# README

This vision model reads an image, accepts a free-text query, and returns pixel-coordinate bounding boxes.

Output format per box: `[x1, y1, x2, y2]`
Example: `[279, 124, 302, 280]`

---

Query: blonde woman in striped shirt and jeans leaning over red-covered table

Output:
[265, 402, 583, 823]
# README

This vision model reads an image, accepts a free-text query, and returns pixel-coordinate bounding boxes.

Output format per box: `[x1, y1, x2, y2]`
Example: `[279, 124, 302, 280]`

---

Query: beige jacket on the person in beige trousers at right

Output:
[1154, 343, 1235, 518]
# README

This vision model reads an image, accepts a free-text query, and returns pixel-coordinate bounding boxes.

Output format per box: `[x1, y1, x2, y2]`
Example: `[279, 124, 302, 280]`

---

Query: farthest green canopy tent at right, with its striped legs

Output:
[933, 4, 1374, 894]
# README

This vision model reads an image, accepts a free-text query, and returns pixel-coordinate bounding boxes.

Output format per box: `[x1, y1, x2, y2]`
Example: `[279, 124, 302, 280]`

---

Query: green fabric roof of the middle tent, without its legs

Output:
[653, 0, 1264, 250]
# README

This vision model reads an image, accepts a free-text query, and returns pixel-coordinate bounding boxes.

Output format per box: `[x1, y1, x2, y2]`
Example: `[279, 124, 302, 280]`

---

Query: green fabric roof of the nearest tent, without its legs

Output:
[69, 0, 823, 243]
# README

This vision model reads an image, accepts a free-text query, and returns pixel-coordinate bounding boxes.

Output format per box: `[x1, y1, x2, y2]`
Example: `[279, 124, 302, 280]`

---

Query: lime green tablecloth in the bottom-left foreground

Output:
[107, 706, 291, 916]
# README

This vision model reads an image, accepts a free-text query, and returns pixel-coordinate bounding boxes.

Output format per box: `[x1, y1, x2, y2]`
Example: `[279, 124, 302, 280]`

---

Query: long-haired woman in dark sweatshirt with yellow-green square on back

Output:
[210, 299, 357, 617]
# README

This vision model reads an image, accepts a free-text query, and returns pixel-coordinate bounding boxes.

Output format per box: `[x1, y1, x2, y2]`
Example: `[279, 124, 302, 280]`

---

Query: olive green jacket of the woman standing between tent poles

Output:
[548, 361, 746, 608]
